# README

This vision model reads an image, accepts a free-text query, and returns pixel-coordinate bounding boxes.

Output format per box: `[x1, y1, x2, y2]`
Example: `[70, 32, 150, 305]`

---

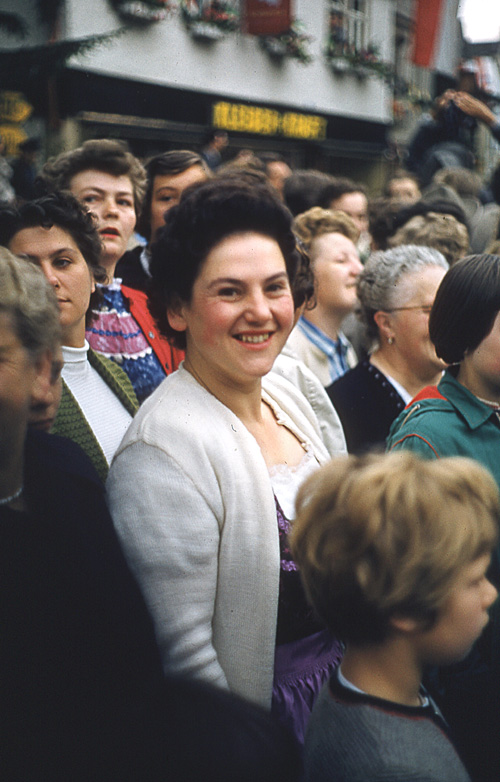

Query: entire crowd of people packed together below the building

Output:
[0, 82, 500, 782]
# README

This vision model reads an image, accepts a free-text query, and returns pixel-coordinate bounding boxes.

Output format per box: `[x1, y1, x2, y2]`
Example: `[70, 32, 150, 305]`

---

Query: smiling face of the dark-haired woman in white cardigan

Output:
[169, 232, 294, 390]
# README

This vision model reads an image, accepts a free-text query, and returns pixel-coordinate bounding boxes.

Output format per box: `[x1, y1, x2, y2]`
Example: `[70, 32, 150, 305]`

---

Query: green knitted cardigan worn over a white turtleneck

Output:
[51, 349, 139, 481]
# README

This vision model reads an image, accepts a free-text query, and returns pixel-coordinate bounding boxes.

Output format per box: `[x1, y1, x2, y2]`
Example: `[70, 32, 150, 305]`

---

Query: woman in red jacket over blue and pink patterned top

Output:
[42, 139, 183, 402]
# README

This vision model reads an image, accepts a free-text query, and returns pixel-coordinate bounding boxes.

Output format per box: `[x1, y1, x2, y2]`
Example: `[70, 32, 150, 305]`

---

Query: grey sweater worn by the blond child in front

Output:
[305, 673, 470, 782]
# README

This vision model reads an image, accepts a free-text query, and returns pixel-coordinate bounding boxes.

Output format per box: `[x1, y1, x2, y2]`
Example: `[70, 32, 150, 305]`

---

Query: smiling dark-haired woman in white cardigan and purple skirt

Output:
[108, 180, 348, 739]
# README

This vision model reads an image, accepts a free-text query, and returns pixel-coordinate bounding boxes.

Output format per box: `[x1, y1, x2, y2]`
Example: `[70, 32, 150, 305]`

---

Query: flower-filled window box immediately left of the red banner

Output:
[180, 0, 240, 40]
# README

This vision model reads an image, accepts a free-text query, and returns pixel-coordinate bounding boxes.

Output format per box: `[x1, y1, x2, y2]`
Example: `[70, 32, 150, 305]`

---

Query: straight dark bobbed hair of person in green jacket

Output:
[429, 253, 500, 364]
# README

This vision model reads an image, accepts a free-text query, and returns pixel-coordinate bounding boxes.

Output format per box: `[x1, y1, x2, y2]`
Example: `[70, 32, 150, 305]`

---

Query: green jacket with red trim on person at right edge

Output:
[387, 370, 500, 487]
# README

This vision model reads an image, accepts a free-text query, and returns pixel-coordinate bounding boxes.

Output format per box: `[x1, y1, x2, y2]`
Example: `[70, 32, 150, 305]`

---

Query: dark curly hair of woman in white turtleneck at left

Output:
[0, 192, 107, 318]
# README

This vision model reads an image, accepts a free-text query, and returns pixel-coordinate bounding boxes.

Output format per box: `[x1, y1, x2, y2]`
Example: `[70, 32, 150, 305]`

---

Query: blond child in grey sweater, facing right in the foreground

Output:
[292, 452, 499, 782]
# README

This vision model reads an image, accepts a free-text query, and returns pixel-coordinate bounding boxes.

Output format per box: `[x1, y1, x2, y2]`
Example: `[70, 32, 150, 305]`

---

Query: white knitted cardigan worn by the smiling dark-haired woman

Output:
[107, 367, 343, 707]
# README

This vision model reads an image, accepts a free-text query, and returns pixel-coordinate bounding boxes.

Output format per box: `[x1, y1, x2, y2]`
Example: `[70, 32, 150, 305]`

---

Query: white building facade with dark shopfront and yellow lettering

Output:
[0, 0, 464, 188]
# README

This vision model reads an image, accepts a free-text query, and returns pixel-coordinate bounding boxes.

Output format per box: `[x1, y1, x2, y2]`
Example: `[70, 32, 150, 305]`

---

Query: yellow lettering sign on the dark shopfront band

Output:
[212, 101, 327, 141]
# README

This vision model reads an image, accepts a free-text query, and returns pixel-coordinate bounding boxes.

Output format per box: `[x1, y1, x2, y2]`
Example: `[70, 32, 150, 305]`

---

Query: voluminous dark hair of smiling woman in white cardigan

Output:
[149, 180, 310, 348]
